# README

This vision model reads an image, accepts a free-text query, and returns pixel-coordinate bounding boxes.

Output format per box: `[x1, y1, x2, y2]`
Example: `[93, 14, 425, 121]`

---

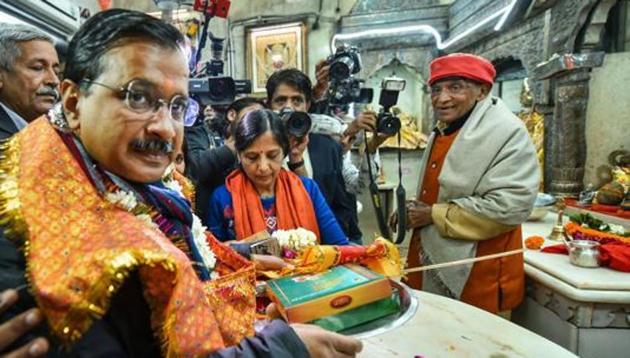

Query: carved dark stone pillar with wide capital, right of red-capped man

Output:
[533, 52, 604, 196]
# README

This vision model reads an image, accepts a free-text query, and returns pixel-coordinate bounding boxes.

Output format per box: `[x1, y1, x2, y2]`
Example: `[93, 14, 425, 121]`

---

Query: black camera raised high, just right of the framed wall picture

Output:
[326, 44, 373, 106]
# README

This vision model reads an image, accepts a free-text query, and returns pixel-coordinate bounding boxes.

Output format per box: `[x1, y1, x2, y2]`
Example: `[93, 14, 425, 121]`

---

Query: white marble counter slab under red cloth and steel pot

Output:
[523, 213, 630, 303]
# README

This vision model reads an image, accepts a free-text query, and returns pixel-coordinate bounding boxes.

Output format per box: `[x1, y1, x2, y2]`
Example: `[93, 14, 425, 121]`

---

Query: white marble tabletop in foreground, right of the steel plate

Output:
[359, 291, 576, 358]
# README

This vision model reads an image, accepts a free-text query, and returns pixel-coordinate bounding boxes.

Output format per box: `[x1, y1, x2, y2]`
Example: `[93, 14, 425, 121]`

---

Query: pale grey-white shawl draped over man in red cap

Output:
[418, 96, 540, 299]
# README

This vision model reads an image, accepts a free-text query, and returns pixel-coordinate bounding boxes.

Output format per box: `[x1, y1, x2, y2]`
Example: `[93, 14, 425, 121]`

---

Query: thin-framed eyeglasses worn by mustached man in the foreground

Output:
[82, 79, 190, 123]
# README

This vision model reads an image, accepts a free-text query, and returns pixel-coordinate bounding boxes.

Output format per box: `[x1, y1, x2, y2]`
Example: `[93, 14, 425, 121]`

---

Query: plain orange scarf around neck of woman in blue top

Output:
[225, 169, 319, 240]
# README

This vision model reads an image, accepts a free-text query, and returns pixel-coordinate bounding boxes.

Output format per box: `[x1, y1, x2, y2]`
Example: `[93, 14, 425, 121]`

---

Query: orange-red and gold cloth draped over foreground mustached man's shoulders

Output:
[0, 118, 255, 356]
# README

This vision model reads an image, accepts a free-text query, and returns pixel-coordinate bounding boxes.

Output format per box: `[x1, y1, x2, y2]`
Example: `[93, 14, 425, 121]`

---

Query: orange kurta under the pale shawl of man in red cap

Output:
[407, 131, 525, 313]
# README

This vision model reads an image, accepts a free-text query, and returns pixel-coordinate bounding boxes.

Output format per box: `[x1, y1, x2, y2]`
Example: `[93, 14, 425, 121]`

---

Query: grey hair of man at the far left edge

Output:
[0, 23, 55, 70]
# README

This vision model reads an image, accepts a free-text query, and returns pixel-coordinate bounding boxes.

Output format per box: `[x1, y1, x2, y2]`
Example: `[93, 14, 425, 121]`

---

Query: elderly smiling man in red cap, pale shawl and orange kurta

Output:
[396, 54, 540, 313]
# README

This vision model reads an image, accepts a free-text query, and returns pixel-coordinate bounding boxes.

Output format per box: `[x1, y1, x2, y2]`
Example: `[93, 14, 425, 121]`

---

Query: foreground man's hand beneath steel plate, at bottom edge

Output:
[291, 323, 363, 358]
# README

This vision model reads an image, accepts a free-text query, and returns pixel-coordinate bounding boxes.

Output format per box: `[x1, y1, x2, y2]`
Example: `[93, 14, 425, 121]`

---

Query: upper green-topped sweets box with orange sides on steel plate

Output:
[267, 265, 392, 323]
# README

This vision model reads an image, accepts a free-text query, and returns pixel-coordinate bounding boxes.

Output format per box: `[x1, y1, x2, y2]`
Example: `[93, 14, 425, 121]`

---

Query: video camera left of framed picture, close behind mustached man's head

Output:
[188, 34, 252, 106]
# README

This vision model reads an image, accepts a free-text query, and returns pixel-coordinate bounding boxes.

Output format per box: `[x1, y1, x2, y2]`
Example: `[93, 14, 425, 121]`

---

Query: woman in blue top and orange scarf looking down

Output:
[207, 109, 349, 245]
